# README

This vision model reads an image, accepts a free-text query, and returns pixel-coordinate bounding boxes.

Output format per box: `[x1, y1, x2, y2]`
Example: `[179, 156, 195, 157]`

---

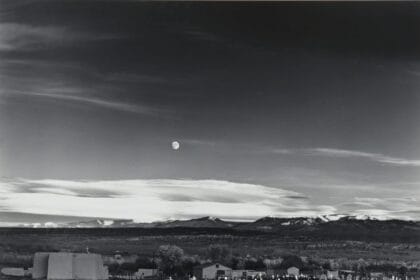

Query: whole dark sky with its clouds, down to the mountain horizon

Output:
[0, 1, 420, 223]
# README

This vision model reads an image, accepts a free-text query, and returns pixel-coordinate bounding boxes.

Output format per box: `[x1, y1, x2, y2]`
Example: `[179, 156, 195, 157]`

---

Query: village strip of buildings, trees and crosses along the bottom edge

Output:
[0, 245, 420, 280]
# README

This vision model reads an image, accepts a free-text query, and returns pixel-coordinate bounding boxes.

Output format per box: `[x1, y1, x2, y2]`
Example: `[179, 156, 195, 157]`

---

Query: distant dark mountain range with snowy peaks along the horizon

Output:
[4, 215, 420, 243]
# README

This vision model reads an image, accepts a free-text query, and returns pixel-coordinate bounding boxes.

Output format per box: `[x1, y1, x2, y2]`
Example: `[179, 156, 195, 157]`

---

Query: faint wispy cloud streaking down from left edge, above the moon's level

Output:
[0, 59, 176, 119]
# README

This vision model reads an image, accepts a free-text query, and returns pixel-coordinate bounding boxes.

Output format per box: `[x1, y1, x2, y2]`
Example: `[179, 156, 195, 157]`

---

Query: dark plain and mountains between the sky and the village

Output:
[0, 217, 420, 270]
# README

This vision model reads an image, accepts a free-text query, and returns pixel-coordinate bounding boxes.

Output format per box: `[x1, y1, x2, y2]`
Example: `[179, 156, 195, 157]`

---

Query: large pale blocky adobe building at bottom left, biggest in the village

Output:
[32, 253, 108, 280]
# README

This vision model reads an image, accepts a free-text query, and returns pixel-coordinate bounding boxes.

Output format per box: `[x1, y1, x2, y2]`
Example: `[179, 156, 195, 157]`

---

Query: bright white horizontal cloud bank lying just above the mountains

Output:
[0, 179, 335, 222]
